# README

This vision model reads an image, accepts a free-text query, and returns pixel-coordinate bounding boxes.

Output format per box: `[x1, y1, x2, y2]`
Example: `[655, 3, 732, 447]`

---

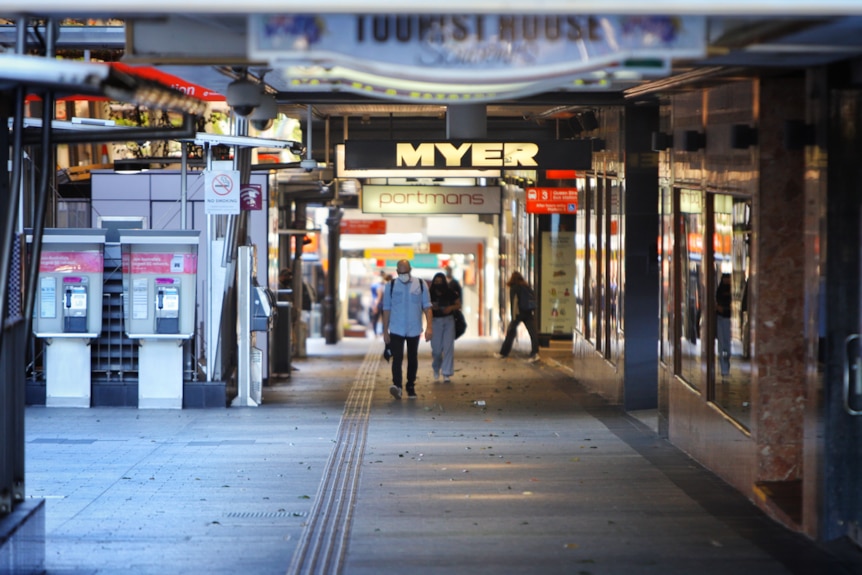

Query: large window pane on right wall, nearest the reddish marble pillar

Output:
[713, 195, 751, 427]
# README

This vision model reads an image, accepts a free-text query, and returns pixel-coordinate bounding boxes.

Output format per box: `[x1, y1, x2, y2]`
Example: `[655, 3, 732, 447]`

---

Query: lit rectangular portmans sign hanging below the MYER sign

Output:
[362, 185, 501, 215]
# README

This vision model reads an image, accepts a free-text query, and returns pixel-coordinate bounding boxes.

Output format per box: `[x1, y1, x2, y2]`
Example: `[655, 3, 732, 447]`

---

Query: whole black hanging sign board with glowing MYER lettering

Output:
[344, 140, 592, 170]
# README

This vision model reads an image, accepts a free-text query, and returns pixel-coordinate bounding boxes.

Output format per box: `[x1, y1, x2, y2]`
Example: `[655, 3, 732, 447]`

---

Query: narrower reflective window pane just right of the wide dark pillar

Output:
[678, 190, 704, 389]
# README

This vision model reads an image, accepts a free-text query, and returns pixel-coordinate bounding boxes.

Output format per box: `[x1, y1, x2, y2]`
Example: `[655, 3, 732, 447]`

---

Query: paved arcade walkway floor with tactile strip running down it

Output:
[26, 339, 862, 575]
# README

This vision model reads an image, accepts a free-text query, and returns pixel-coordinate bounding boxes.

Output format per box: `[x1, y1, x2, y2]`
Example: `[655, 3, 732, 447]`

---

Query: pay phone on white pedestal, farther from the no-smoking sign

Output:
[27, 228, 107, 407]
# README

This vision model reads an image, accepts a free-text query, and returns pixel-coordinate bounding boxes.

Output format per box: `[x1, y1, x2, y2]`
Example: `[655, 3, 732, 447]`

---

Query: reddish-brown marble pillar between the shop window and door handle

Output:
[751, 75, 806, 481]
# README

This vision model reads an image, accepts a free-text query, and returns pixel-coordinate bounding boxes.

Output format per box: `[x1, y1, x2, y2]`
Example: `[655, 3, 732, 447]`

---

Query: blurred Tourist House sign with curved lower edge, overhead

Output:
[248, 14, 706, 100]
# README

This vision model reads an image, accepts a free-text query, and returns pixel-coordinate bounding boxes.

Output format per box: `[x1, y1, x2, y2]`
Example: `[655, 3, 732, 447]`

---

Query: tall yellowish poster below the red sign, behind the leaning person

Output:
[539, 232, 575, 335]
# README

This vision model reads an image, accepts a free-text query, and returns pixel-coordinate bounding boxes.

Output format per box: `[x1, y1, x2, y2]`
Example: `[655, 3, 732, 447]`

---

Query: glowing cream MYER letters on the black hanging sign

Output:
[395, 142, 539, 168]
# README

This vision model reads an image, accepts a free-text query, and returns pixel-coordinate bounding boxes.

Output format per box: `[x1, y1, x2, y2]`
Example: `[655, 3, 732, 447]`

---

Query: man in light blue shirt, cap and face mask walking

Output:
[383, 260, 433, 399]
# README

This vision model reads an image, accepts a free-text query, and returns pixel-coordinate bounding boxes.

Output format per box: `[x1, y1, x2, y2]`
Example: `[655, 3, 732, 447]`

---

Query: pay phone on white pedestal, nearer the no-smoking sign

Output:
[120, 230, 200, 409]
